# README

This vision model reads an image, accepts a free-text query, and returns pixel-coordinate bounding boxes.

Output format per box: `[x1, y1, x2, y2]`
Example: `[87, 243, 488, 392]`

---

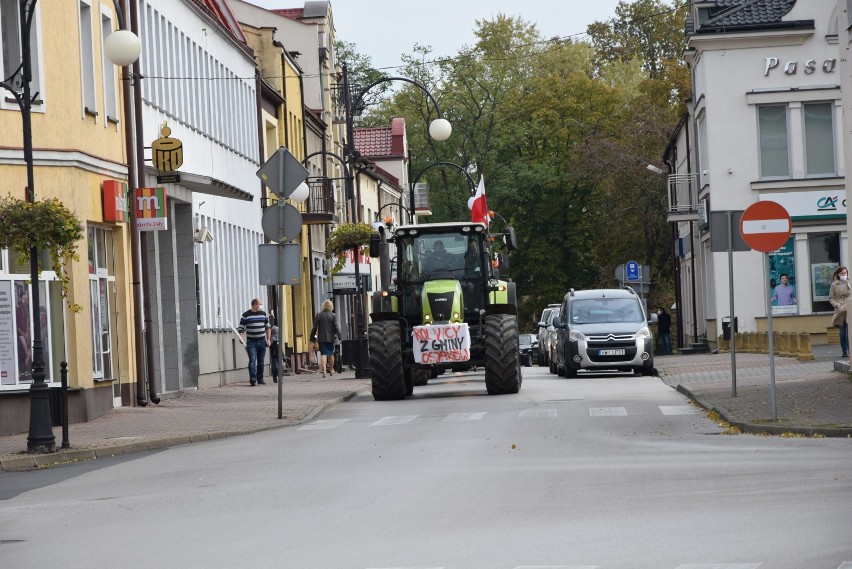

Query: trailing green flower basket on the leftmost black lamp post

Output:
[0, 196, 83, 312]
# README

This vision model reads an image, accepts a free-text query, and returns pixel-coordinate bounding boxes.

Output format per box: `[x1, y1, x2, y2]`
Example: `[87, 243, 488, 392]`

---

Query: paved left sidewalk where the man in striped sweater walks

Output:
[0, 370, 370, 471]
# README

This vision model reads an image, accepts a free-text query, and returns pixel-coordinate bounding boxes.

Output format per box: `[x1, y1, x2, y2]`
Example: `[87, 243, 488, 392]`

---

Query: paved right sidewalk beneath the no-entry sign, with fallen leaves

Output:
[654, 346, 852, 437]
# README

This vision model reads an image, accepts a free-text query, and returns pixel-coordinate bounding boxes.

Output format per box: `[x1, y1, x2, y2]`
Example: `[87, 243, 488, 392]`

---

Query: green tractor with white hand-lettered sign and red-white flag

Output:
[369, 222, 522, 401]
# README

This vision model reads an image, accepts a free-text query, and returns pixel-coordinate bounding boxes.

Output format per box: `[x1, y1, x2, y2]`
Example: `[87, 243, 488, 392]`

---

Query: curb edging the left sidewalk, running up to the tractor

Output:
[0, 385, 371, 472]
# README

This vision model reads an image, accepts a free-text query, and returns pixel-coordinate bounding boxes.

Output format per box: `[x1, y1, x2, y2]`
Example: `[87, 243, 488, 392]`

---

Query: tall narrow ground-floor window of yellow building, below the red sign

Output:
[86, 225, 118, 380]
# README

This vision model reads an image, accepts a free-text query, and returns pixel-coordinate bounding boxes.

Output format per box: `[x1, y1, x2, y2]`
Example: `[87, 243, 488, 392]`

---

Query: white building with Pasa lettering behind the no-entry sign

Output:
[666, 0, 848, 348]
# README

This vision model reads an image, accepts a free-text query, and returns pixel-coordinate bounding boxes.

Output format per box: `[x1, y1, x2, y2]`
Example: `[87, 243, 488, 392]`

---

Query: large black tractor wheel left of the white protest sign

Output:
[369, 320, 407, 401]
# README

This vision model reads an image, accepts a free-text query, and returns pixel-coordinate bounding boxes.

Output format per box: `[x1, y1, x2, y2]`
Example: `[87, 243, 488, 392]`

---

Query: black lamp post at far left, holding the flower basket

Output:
[0, 0, 138, 454]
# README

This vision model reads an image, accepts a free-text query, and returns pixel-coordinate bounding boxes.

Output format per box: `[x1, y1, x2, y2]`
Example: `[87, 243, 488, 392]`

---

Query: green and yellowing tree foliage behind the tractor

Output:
[336, 0, 689, 328]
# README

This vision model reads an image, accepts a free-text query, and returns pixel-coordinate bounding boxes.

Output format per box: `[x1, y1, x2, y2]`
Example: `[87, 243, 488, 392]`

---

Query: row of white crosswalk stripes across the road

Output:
[299, 405, 700, 428]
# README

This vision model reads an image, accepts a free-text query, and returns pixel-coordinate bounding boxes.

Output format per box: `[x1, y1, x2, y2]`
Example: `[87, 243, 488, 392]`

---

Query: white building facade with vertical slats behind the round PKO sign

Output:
[138, 0, 268, 393]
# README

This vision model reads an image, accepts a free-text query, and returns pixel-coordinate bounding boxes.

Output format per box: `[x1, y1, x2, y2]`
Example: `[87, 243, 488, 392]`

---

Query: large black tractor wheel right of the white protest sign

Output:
[485, 314, 522, 395]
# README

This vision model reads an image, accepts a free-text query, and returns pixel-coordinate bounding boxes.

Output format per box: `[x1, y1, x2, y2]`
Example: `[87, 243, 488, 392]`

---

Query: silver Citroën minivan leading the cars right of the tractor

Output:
[551, 287, 657, 377]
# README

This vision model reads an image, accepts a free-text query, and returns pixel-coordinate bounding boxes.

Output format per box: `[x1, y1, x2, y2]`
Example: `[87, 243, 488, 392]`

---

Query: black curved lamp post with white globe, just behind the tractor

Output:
[342, 63, 453, 378]
